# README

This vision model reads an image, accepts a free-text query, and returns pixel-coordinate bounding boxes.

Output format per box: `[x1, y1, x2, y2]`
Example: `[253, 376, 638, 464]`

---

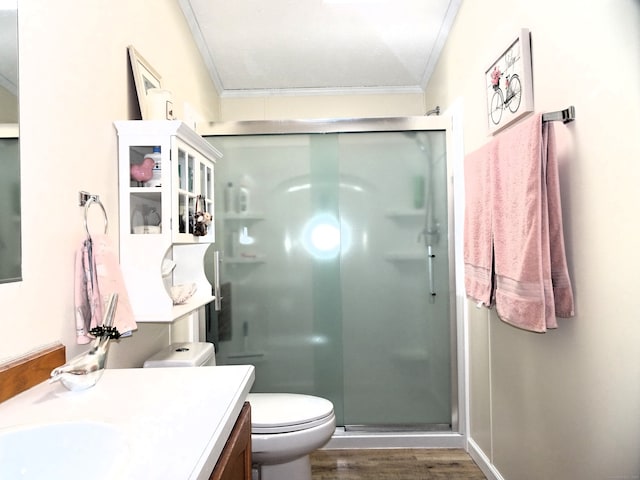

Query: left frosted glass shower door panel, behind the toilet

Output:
[205, 135, 343, 421]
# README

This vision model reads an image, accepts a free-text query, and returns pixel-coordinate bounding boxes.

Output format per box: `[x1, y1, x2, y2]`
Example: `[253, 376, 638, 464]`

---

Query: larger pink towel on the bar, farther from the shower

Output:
[492, 114, 573, 332]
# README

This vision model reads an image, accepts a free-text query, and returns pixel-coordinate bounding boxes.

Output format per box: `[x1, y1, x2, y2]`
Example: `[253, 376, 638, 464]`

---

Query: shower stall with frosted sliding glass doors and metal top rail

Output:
[205, 117, 458, 446]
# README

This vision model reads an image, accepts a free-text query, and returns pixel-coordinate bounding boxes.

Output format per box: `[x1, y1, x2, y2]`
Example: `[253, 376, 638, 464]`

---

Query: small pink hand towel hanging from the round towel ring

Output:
[75, 234, 138, 344]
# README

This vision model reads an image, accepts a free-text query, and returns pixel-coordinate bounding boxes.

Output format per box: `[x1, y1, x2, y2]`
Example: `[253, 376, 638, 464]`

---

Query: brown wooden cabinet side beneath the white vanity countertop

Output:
[209, 402, 251, 480]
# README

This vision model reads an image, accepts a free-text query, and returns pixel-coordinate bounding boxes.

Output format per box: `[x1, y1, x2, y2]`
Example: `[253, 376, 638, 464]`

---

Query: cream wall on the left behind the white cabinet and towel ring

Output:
[0, 0, 219, 366]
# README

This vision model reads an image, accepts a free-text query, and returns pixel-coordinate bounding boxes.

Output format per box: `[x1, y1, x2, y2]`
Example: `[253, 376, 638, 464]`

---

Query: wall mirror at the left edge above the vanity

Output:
[0, 0, 22, 283]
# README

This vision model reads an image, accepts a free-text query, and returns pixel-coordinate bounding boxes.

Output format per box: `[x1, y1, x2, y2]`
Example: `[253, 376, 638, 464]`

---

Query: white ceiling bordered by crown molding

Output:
[179, 0, 462, 97]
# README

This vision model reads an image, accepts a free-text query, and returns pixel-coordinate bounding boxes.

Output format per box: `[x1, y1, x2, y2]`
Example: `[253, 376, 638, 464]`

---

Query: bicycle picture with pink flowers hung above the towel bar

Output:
[484, 28, 533, 134]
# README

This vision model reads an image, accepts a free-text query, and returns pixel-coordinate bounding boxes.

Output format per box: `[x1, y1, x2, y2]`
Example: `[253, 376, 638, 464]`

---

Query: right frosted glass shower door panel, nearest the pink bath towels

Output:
[339, 131, 451, 430]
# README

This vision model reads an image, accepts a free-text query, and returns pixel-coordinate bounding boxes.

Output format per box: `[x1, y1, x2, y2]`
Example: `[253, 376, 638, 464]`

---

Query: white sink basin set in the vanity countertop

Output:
[0, 421, 128, 480]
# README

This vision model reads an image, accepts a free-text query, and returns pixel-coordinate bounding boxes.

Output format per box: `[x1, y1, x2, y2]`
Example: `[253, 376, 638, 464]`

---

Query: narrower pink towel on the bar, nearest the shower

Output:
[464, 142, 496, 307]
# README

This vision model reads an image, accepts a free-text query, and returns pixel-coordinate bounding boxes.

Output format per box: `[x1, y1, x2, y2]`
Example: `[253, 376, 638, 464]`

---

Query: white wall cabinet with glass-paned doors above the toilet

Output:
[115, 120, 222, 322]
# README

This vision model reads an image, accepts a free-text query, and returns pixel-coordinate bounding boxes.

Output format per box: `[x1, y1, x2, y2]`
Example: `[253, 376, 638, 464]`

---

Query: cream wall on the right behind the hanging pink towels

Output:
[425, 0, 640, 480]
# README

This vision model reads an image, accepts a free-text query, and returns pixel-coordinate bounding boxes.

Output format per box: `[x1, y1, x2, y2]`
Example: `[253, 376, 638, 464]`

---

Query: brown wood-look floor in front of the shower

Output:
[311, 449, 486, 480]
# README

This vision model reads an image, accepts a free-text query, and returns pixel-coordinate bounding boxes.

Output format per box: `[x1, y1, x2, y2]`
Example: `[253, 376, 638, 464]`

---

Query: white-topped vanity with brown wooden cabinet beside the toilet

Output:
[0, 346, 255, 480]
